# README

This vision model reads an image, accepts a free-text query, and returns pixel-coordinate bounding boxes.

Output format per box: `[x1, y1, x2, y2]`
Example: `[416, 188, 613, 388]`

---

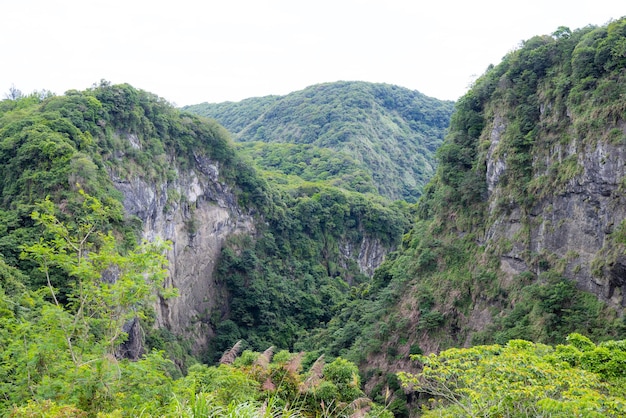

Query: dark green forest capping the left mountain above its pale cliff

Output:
[0, 81, 268, 301]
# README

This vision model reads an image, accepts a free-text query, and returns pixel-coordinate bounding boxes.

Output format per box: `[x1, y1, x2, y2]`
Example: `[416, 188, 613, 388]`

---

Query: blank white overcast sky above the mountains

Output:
[0, 0, 626, 106]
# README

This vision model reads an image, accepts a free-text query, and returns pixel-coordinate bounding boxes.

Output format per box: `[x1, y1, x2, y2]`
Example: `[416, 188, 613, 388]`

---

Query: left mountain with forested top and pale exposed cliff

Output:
[0, 83, 264, 352]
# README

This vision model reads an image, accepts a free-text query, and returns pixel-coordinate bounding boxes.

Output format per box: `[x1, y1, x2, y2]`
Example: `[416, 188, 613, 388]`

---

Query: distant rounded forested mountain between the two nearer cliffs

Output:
[184, 82, 453, 202]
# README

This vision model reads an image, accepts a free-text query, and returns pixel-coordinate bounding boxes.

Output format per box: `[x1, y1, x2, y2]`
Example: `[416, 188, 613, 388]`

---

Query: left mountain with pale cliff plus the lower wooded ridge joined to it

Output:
[0, 82, 407, 358]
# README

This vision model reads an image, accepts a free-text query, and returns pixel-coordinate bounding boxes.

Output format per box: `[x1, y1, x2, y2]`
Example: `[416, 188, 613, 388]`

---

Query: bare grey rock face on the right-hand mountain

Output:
[485, 112, 626, 308]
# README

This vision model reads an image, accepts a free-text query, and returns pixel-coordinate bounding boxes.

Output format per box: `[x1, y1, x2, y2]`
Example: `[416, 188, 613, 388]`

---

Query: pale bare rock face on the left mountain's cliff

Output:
[113, 149, 255, 349]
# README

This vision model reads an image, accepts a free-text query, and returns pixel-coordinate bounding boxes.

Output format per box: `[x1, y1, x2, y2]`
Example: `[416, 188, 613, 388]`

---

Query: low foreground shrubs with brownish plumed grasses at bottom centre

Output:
[171, 349, 390, 418]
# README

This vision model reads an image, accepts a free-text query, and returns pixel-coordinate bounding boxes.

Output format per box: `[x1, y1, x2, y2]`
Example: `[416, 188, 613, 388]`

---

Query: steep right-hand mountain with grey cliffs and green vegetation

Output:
[302, 19, 626, 412]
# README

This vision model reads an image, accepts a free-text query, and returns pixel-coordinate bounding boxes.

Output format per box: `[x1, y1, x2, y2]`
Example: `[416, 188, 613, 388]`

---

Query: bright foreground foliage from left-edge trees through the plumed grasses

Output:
[0, 191, 388, 417]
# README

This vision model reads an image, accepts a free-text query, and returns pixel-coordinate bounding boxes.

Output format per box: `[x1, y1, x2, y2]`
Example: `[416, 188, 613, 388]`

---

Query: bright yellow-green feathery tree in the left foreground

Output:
[0, 191, 174, 416]
